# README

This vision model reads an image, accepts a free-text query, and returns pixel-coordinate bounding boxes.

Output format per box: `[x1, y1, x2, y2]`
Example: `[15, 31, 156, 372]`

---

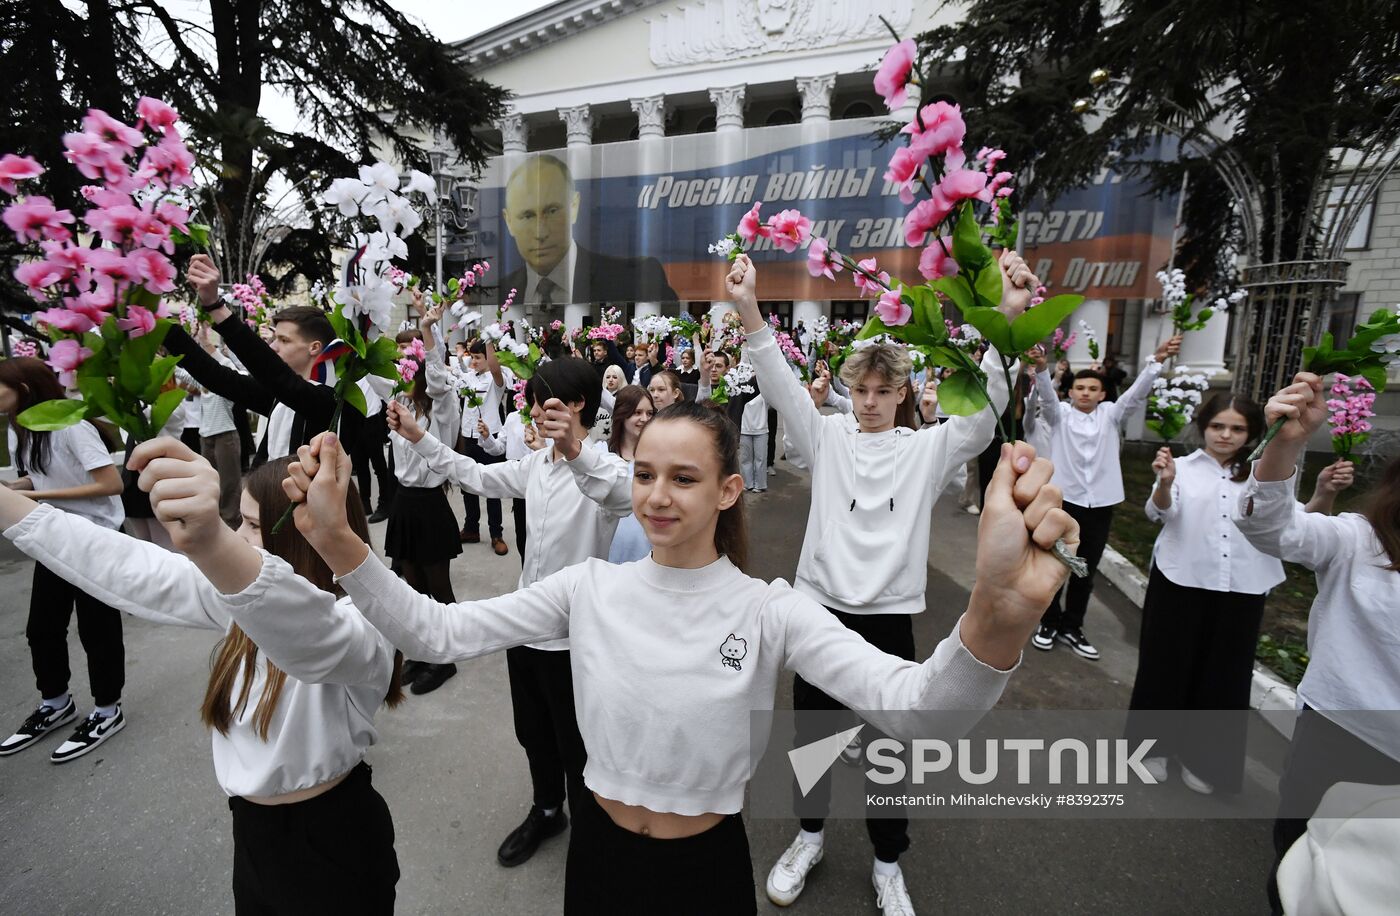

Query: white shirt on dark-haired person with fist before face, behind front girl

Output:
[413, 436, 631, 651]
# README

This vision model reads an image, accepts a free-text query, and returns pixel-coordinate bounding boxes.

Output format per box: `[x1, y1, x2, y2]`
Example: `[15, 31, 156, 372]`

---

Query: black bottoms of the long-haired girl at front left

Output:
[228, 761, 399, 916]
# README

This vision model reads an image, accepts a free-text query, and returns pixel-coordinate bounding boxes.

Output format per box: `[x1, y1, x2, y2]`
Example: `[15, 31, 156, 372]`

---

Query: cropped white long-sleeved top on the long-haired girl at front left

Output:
[4, 506, 393, 797]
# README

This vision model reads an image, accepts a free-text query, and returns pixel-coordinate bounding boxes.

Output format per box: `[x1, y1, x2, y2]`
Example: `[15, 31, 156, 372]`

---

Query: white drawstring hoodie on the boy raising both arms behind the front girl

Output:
[749, 328, 1007, 613]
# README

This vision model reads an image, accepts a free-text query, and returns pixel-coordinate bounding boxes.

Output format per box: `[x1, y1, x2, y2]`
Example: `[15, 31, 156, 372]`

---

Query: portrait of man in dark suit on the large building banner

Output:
[500, 155, 676, 308]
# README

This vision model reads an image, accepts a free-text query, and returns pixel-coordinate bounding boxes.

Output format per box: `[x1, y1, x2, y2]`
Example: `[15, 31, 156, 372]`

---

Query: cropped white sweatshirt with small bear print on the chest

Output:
[317, 553, 1011, 815]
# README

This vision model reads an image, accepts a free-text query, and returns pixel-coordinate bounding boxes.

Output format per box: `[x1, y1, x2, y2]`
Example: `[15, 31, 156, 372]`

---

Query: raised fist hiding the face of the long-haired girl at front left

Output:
[126, 437, 232, 557]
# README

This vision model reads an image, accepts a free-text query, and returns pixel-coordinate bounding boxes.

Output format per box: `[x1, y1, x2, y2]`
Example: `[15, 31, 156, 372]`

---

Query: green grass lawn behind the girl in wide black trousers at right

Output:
[1109, 443, 1383, 683]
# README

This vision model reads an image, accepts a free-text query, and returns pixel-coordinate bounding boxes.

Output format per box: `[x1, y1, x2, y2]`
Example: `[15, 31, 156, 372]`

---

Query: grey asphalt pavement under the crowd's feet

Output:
[0, 450, 1273, 916]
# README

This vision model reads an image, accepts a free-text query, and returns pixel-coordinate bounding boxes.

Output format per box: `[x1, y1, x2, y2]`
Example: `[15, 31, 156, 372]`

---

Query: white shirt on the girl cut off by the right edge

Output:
[1235, 471, 1400, 761]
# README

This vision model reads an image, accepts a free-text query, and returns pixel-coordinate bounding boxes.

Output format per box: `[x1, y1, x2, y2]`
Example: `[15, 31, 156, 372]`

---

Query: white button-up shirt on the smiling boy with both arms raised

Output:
[1036, 357, 1162, 508]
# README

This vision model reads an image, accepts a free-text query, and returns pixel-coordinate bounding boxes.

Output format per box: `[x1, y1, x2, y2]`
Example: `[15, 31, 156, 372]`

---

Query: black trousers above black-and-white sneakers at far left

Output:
[24, 563, 126, 706]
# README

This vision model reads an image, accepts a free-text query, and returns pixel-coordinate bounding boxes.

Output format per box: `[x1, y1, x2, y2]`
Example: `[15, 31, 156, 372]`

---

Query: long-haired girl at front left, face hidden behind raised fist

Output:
[0, 438, 402, 916]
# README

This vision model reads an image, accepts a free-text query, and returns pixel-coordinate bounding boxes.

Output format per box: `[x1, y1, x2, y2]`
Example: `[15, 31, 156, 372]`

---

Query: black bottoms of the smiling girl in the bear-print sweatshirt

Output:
[564, 791, 757, 916]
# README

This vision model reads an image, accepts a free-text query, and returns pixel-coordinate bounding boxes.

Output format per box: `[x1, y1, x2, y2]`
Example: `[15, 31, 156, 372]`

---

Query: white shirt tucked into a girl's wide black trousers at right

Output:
[1147, 448, 1284, 595]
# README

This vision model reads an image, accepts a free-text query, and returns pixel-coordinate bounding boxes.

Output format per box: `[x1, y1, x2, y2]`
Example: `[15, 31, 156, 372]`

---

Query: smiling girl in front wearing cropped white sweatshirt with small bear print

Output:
[263, 403, 1077, 913]
